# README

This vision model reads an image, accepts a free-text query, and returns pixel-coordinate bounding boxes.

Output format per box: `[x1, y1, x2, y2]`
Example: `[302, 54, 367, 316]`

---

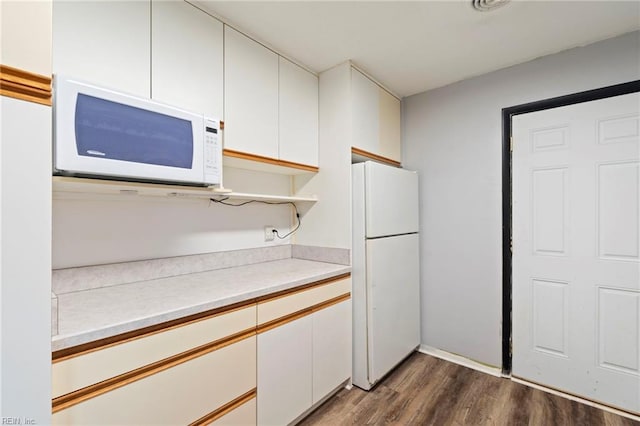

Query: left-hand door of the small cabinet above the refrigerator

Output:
[351, 68, 380, 155]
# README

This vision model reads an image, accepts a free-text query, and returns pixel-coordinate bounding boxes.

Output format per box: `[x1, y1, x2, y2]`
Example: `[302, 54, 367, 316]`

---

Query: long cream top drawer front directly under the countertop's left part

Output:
[52, 305, 256, 398]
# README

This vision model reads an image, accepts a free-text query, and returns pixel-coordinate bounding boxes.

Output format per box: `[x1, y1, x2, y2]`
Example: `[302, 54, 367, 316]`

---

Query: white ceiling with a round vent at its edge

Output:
[194, 0, 640, 97]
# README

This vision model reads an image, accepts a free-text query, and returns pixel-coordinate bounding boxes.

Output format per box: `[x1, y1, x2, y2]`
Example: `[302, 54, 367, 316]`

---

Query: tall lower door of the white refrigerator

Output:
[366, 234, 420, 384]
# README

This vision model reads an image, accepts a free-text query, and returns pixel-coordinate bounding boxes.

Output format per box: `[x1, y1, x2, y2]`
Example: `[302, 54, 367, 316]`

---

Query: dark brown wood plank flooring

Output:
[300, 352, 640, 426]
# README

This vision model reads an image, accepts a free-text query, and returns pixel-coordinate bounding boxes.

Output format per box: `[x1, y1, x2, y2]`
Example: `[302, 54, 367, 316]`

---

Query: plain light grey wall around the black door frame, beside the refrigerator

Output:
[402, 32, 640, 366]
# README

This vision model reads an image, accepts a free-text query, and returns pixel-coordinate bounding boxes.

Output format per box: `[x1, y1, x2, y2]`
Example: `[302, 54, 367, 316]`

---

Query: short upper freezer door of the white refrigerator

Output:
[365, 162, 419, 238]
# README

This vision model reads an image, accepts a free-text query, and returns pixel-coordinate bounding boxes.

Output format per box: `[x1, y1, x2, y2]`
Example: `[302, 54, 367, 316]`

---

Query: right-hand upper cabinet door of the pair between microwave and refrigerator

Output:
[279, 57, 318, 166]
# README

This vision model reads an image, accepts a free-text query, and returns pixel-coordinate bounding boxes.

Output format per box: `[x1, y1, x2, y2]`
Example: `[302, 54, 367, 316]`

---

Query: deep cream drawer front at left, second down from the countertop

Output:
[52, 336, 256, 425]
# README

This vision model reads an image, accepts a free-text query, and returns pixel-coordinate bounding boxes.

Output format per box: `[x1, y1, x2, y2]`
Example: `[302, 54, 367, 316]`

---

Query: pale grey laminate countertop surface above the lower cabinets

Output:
[52, 258, 351, 351]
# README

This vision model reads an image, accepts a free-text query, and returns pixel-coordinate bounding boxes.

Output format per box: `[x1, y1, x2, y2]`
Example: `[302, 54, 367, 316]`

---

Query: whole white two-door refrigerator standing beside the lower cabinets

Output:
[352, 161, 420, 390]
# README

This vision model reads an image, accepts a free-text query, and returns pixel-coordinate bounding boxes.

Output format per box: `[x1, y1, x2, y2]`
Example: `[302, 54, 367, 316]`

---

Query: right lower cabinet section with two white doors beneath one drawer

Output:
[258, 278, 351, 426]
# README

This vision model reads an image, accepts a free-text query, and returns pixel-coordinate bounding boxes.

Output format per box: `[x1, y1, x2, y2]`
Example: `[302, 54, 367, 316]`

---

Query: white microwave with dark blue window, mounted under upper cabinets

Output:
[53, 76, 222, 186]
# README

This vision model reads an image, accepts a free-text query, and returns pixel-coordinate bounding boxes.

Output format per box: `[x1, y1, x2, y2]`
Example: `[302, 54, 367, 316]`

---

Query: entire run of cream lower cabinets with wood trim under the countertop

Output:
[52, 276, 351, 426]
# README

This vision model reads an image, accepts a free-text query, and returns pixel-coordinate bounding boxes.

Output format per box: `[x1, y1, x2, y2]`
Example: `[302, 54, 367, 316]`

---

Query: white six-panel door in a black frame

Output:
[512, 93, 640, 413]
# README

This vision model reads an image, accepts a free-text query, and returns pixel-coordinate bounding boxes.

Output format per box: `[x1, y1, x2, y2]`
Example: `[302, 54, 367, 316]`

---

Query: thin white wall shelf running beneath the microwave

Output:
[53, 176, 318, 203]
